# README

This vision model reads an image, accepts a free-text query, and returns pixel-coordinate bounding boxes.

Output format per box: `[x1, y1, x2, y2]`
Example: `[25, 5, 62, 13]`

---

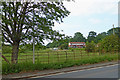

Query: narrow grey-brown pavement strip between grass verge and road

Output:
[2, 61, 118, 80]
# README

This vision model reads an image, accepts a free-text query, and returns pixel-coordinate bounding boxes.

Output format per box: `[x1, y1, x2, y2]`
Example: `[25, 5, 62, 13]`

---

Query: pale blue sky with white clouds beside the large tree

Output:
[45, 0, 119, 44]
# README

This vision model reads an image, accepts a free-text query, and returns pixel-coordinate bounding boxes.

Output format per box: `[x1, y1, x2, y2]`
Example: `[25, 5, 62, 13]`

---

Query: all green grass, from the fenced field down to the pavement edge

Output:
[2, 50, 118, 74]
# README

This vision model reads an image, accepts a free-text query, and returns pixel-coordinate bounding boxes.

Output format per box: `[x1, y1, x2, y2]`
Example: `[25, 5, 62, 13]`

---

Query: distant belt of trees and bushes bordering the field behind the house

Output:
[2, 27, 120, 53]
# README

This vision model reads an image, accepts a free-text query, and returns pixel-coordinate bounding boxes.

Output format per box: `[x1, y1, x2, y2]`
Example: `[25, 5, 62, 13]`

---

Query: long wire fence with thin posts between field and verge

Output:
[2, 50, 118, 64]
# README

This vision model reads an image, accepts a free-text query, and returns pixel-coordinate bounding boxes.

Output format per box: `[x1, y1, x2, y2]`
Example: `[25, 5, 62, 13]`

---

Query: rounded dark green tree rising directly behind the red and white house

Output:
[71, 32, 86, 42]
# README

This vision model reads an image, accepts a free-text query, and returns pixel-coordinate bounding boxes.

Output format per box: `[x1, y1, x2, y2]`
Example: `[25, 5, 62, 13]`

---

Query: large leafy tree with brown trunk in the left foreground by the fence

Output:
[0, 2, 70, 63]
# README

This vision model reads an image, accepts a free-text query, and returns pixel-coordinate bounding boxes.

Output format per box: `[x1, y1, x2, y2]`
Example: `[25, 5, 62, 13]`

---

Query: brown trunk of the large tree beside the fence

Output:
[11, 43, 19, 64]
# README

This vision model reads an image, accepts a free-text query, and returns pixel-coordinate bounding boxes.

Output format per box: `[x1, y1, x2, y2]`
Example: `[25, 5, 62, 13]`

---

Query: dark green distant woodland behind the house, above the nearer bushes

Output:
[46, 27, 120, 49]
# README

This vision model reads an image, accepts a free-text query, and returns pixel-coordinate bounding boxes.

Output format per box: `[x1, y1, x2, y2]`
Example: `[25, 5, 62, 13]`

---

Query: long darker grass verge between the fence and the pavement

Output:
[2, 54, 118, 74]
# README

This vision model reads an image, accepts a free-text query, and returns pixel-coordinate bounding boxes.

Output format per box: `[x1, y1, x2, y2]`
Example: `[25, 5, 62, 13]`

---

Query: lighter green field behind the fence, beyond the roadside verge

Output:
[3, 50, 99, 63]
